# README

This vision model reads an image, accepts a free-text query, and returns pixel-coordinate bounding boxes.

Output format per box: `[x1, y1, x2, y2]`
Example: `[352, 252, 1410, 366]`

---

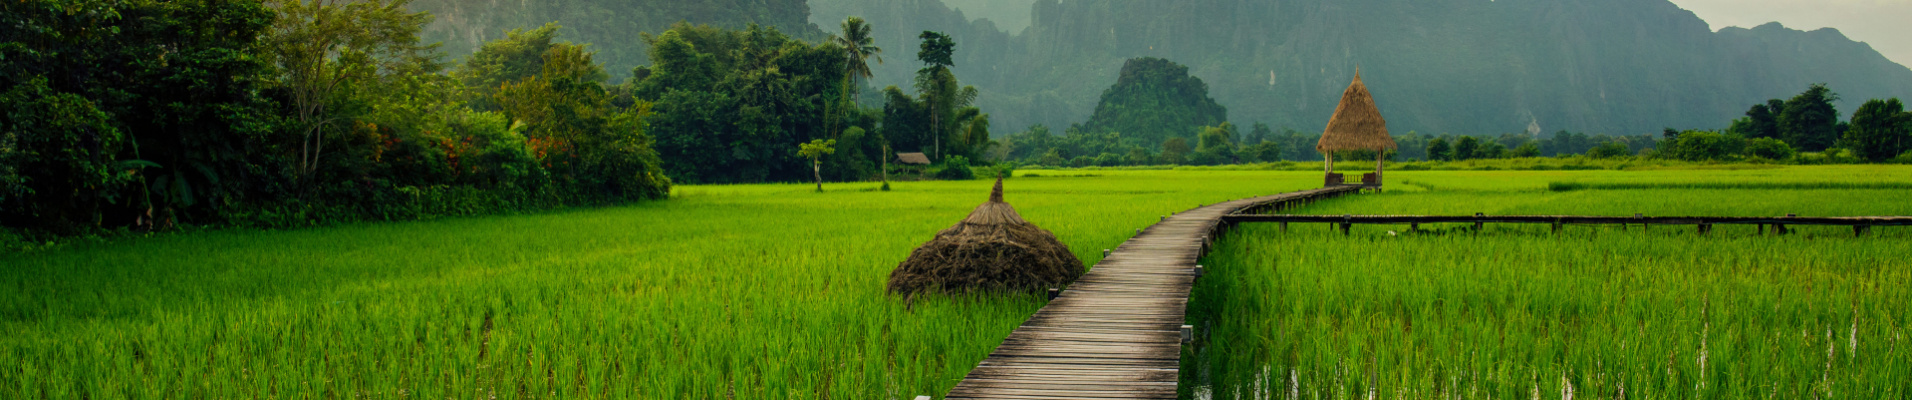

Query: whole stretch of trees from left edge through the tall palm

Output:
[0, 0, 1024, 235]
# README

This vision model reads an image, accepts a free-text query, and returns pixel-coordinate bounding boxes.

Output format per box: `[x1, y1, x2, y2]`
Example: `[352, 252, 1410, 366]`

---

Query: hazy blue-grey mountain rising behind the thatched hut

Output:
[813, 0, 1912, 134]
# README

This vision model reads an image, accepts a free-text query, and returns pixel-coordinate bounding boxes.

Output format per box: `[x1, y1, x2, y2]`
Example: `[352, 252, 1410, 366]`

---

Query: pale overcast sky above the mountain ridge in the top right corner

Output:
[1671, 0, 1912, 65]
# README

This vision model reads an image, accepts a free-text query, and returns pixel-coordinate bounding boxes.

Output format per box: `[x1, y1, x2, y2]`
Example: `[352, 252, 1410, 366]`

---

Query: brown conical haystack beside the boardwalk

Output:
[889, 178, 1084, 295]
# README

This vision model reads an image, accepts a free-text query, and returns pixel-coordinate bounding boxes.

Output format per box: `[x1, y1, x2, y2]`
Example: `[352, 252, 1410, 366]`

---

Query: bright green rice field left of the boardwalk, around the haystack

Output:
[0, 170, 1315, 400]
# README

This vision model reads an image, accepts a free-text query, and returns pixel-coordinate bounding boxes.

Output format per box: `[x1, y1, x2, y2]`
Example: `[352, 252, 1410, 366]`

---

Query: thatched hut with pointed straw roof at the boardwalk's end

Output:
[1315, 69, 1396, 188]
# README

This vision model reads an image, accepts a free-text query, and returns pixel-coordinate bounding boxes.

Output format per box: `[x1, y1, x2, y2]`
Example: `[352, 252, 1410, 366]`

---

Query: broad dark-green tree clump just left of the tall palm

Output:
[633, 23, 848, 184]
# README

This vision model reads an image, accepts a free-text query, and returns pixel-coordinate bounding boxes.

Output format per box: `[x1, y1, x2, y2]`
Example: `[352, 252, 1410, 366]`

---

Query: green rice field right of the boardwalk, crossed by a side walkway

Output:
[1182, 168, 1912, 398]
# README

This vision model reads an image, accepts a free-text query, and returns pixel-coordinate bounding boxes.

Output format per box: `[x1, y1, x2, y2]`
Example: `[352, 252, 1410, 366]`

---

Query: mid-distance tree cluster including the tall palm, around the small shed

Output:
[631, 17, 994, 184]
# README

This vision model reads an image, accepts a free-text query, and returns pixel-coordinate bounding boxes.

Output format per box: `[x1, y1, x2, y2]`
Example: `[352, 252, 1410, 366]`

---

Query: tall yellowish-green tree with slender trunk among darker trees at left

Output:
[266, 0, 436, 187]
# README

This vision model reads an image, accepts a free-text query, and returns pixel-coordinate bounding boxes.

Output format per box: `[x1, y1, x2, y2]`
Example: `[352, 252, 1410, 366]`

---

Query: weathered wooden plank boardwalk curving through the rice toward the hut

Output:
[945, 186, 1359, 400]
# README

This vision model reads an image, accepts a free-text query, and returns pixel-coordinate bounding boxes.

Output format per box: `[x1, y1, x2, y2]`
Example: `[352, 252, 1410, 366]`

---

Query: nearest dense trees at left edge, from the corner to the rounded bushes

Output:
[0, 0, 671, 233]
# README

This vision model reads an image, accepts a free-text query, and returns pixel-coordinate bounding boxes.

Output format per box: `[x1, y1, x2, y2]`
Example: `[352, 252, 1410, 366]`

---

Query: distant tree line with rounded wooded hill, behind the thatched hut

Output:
[996, 67, 1912, 167]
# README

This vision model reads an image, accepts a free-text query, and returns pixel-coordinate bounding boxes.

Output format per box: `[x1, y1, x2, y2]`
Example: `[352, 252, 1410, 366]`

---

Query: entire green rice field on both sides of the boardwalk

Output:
[0, 167, 1912, 398]
